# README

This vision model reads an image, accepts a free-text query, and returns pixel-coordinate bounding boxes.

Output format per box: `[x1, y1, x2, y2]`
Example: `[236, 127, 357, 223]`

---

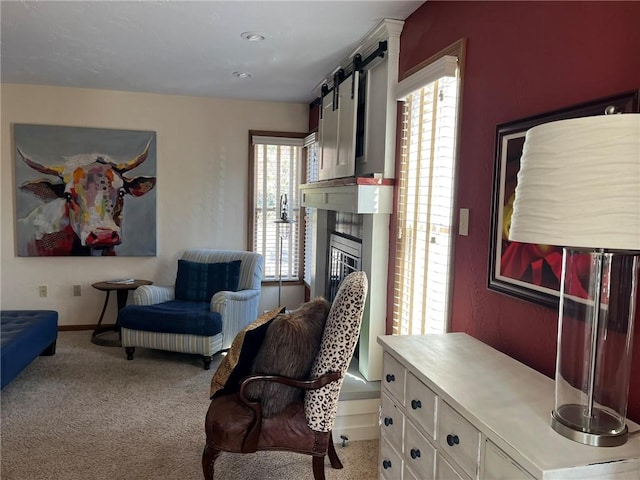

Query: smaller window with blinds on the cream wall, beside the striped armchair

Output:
[249, 132, 304, 281]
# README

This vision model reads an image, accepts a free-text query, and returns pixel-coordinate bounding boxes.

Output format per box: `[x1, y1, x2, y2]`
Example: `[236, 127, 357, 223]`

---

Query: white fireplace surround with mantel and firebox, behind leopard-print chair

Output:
[301, 178, 393, 381]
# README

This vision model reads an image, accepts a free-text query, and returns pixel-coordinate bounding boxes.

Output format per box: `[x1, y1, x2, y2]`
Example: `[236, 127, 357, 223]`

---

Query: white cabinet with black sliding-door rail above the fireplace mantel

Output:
[318, 19, 404, 186]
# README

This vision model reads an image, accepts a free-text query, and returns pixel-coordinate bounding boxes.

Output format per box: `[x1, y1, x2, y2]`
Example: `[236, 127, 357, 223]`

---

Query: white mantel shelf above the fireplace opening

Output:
[300, 177, 394, 214]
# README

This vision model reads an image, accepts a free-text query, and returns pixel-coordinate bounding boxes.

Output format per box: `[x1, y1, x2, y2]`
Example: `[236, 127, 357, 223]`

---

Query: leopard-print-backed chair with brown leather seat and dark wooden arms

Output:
[202, 272, 367, 480]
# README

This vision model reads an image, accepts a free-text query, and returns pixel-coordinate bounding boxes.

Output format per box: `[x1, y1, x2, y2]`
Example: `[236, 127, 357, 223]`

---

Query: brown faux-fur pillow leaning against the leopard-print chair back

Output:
[245, 297, 331, 417]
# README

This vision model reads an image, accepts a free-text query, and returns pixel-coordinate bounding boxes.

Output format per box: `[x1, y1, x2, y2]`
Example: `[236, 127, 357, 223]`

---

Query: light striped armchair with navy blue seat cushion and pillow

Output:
[118, 249, 264, 370]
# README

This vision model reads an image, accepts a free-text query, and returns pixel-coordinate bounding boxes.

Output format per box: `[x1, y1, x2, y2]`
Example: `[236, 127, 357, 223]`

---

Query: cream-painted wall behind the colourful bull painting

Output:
[0, 84, 308, 325]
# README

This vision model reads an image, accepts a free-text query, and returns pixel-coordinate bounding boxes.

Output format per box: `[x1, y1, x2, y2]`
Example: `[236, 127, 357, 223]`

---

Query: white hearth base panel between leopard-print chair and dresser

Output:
[333, 398, 380, 444]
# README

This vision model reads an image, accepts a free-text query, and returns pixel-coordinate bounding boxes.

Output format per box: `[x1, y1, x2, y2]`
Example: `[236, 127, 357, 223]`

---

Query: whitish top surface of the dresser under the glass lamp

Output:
[378, 333, 640, 470]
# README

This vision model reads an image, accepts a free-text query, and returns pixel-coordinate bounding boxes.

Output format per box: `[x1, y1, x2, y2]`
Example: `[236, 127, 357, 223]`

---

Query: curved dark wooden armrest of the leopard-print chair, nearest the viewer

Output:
[239, 372, 342, 453]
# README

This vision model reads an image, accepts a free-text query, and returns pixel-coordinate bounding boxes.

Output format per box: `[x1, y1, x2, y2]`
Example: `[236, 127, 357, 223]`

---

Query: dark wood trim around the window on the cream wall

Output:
[246, 130, 308, 286]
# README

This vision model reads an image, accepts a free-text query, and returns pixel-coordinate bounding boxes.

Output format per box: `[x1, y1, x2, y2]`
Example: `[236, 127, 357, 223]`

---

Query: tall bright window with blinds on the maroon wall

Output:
[393, 56, 459, 335]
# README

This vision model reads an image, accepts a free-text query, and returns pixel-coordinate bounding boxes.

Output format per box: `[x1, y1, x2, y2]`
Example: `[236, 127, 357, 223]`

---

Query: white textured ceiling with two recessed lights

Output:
[0, 0, 424, 102]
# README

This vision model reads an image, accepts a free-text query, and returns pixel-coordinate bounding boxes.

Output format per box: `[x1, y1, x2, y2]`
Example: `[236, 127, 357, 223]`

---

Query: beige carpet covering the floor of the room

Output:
[1, 332, 378, 480]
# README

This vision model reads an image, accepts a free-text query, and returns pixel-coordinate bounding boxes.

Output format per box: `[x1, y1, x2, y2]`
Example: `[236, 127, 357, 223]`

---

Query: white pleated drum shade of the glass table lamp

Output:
[509, 113, 640, 251]
